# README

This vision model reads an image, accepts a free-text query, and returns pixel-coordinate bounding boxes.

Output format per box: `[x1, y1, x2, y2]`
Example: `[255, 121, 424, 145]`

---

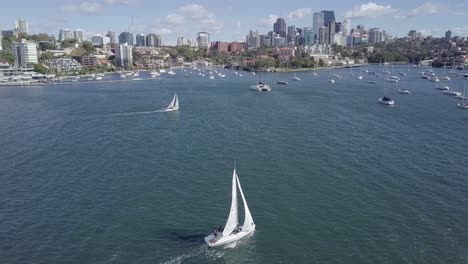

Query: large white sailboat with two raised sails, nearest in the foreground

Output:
[205, 168, 255, 247]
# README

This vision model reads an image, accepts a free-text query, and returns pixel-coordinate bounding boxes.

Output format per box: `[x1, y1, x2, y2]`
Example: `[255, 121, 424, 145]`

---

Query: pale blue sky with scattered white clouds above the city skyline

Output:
[0, 0, 468, 45]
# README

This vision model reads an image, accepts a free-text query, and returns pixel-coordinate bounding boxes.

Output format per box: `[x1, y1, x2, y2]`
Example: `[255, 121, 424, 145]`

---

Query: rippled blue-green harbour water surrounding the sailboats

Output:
[0, 68, 468, 264]
